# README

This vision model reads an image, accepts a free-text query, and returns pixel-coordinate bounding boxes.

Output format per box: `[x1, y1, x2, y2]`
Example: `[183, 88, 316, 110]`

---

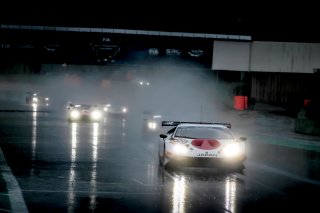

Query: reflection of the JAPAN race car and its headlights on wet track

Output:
[164, 167, 244, 213]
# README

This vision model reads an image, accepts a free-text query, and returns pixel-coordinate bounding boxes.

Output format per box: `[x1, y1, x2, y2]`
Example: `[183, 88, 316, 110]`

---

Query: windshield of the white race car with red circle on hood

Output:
[174, 126, 233, 139]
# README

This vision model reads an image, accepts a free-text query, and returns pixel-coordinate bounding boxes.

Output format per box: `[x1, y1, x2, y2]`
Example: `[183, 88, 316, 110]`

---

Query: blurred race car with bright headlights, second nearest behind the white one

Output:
[67, 103, 104, 122]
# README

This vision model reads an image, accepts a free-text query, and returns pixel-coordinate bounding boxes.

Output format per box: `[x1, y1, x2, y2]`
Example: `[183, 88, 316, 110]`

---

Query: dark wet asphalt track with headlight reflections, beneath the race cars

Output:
[0, 104, 320, 212]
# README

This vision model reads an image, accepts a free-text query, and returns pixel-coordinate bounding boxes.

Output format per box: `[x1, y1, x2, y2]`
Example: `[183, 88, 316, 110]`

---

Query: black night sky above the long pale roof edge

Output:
[0, 1, 320, 42]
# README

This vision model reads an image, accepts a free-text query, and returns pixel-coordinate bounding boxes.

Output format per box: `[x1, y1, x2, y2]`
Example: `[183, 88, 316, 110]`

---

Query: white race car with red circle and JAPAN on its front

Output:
[159, 121, 246, 168]
